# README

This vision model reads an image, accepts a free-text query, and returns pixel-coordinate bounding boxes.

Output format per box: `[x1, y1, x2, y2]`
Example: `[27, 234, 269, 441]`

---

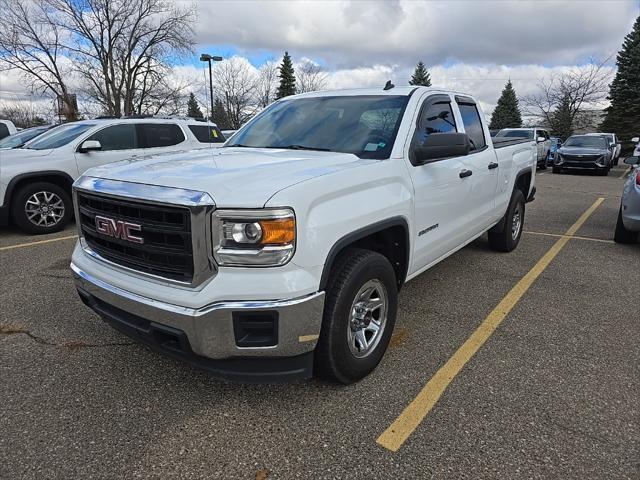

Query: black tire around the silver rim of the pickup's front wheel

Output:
[314, 249, 398, 384]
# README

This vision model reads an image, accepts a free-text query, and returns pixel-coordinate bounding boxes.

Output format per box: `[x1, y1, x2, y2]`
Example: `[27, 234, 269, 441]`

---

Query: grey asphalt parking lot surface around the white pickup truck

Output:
[0, 166, 640, 479]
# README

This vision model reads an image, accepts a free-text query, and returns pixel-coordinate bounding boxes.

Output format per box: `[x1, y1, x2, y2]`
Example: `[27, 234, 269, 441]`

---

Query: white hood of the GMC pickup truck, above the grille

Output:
[85, 147, 360, 208]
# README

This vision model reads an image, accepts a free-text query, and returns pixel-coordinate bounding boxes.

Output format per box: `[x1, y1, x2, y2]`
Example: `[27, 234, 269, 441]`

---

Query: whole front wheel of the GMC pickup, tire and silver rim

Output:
[314, 249, 398, 384]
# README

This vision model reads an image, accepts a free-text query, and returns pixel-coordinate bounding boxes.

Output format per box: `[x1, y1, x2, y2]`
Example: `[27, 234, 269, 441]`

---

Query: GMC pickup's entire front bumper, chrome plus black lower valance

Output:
[71, 264, 324, 382]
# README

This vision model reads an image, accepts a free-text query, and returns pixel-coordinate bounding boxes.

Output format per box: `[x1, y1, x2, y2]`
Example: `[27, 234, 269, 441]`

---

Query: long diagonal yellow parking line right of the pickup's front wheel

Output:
[376, 197, 604, 452]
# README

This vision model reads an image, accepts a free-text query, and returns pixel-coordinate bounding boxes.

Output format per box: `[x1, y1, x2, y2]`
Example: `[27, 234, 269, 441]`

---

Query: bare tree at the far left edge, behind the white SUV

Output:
[0, 0, 74, 119]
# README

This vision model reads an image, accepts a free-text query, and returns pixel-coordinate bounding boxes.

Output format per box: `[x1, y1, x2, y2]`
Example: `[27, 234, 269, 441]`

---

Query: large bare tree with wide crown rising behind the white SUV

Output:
[47, 0, 195, 115]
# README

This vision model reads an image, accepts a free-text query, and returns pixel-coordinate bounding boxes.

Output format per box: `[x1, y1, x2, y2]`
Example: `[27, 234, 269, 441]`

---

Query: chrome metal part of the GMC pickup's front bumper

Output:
[71, 264, 324, 360]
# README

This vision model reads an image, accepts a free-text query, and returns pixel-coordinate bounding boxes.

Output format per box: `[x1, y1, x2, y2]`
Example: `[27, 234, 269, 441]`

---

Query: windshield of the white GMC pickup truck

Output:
[225, 95, 409, 159]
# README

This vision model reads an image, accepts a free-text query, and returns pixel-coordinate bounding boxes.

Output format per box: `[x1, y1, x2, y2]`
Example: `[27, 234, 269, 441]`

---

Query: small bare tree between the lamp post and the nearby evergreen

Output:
[213, 57, 257, 129]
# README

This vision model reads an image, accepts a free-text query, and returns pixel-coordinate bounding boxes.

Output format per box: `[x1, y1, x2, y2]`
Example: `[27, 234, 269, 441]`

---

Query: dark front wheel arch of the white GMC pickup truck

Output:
[319, 216, 410, 290]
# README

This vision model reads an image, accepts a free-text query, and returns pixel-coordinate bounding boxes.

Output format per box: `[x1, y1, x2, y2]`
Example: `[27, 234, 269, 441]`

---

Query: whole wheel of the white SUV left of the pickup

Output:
[11, 182, 73, 234]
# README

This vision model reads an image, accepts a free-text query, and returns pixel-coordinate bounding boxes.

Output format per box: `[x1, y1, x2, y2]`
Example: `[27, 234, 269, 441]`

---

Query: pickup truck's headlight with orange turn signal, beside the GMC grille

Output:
[213, 208, 296, 267]
